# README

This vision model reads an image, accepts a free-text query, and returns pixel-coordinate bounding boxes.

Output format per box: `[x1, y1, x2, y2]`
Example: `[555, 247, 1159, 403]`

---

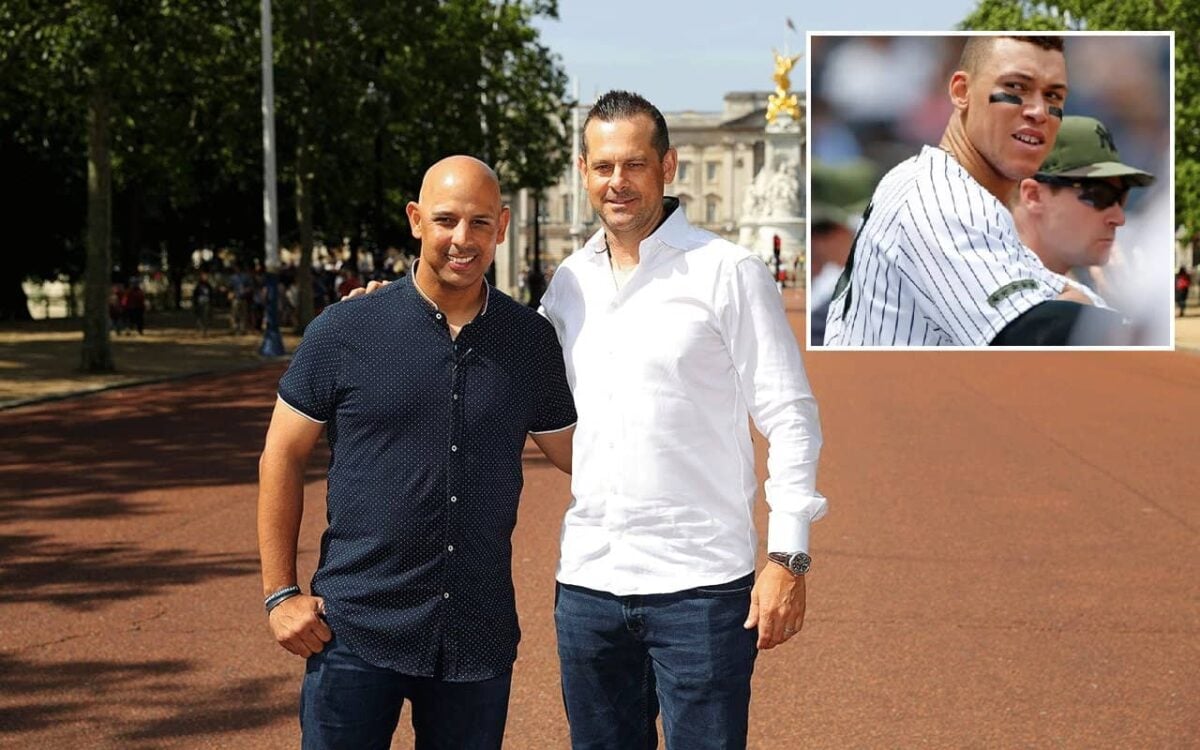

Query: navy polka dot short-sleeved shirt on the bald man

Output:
[280, 276, 575, 682]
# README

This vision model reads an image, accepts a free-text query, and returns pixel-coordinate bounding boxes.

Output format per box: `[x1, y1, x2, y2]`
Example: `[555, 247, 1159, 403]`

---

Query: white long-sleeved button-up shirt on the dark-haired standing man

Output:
[542, 201, 826, 595]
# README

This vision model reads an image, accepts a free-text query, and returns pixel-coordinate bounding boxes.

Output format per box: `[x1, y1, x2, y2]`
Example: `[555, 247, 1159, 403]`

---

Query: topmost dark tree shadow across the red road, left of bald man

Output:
[0, 367, 320, 508]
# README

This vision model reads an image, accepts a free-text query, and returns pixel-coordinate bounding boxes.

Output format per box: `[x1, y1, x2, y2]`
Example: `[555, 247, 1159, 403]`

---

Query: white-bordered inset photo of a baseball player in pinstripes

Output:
[805, 31, 1178, 349]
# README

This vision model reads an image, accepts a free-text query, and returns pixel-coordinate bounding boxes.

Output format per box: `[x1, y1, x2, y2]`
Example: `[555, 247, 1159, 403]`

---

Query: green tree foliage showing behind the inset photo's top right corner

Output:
[961, 0, 1200, 253]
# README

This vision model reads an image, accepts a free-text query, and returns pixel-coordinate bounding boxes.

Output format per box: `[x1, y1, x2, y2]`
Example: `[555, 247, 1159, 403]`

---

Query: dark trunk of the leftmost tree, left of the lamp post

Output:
[80, 83, 115, 372]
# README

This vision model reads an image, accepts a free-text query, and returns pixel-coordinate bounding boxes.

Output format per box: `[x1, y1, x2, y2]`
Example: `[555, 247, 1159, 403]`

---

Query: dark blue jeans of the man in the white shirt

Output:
[554, 574, 758, 750]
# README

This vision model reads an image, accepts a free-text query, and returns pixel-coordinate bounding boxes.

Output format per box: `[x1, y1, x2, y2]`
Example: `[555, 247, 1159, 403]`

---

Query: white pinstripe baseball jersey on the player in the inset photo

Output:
[824, 146, 1066, 347]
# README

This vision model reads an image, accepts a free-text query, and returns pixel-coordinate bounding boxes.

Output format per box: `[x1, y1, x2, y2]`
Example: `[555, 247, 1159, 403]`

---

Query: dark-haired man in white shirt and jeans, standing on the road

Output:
[542, 91, 826, 750]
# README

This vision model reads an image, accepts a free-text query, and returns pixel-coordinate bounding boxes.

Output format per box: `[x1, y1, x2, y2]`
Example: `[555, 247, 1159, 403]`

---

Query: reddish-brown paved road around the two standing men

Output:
[0, 300, 1200, 749]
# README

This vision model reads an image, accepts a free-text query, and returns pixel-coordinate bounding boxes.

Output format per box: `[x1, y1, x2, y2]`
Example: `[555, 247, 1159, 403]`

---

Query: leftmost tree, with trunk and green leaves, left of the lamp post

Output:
[0, 0, 262, 372]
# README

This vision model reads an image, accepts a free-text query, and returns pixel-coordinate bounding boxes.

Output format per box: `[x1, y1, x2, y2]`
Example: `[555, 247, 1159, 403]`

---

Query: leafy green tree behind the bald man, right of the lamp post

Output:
[276, 0, 569, 329]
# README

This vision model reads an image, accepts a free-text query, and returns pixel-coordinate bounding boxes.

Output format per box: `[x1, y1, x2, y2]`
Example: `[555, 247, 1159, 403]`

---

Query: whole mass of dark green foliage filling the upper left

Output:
[0, 0, 568, 268]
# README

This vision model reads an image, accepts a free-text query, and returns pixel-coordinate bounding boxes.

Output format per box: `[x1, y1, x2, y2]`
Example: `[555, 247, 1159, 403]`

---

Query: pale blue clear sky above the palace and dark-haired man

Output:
[538, 0, 977, 112]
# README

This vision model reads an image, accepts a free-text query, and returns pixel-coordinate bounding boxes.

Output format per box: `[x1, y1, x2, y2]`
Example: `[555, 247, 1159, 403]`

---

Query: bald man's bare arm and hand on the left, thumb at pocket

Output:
[258, 400, 332, 656]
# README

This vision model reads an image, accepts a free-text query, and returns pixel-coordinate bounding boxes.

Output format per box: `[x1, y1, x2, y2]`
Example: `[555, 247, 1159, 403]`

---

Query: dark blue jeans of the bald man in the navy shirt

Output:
[300, 635, 512, 750]
